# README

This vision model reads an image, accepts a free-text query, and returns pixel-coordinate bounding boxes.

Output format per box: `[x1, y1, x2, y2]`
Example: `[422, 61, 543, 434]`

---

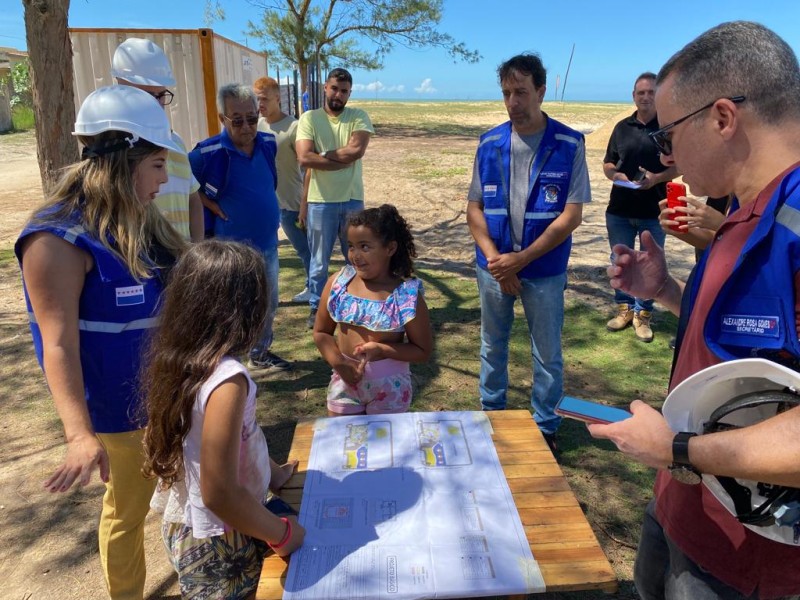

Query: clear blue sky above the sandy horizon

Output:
[0, 0, 800, 101]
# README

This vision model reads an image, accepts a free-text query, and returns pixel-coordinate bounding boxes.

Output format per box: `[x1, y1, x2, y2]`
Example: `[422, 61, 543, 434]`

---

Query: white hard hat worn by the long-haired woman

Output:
[72, 85, 183, 153]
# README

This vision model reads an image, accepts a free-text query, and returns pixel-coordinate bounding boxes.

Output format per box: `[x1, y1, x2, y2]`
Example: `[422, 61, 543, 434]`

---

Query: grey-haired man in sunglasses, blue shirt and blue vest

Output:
[189, 83, 291, 371]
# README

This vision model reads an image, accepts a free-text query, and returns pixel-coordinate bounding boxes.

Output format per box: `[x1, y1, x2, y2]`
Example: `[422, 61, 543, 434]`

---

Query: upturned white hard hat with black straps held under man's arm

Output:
[662, 358, 800, 545]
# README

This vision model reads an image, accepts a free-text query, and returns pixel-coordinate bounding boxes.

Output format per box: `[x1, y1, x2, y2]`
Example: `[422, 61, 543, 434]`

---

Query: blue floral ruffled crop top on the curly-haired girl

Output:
[328, 265, 424, 332]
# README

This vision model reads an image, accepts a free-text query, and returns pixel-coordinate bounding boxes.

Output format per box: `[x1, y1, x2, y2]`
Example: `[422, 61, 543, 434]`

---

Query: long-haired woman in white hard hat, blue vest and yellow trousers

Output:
[15, 86, 184, 599]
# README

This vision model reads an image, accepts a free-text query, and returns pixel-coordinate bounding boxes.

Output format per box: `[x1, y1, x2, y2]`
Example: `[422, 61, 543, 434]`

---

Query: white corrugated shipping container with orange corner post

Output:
[69, 28, 267, 150]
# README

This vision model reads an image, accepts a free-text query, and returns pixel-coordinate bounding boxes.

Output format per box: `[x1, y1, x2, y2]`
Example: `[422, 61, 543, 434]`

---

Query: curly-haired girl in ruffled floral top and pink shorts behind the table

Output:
[314, 204, 433, 416]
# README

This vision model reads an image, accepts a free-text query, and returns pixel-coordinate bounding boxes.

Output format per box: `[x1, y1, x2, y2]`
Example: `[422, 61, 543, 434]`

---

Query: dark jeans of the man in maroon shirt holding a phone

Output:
[633, 500, 776, 600]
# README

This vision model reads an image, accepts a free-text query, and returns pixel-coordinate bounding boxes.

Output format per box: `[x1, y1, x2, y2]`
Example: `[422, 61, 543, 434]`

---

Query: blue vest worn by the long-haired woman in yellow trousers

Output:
[14, 213, 167, 433]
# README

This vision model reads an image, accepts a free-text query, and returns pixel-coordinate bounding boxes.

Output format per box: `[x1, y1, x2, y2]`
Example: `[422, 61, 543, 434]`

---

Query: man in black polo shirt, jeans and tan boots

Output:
[603, 73, 677, 342]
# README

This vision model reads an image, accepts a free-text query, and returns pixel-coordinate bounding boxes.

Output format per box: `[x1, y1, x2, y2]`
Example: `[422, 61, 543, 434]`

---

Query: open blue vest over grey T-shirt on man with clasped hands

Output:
[475, 117, 583, 279]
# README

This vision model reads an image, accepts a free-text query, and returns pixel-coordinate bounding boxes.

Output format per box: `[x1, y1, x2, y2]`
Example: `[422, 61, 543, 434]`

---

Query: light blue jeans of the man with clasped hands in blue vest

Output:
[477, 267, 567, 433]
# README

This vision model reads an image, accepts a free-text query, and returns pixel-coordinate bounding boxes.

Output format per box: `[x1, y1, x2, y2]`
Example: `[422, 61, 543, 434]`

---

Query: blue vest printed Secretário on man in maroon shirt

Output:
[690, 168, 800, 369]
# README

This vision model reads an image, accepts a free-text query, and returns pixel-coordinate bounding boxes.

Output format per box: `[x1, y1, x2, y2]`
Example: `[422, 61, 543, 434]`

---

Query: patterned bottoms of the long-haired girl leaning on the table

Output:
[161, 496, 297, 600]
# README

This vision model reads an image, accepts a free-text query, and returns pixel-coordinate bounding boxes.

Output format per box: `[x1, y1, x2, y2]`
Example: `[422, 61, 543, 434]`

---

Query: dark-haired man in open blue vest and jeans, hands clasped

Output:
[467, 54, 591, 451]
